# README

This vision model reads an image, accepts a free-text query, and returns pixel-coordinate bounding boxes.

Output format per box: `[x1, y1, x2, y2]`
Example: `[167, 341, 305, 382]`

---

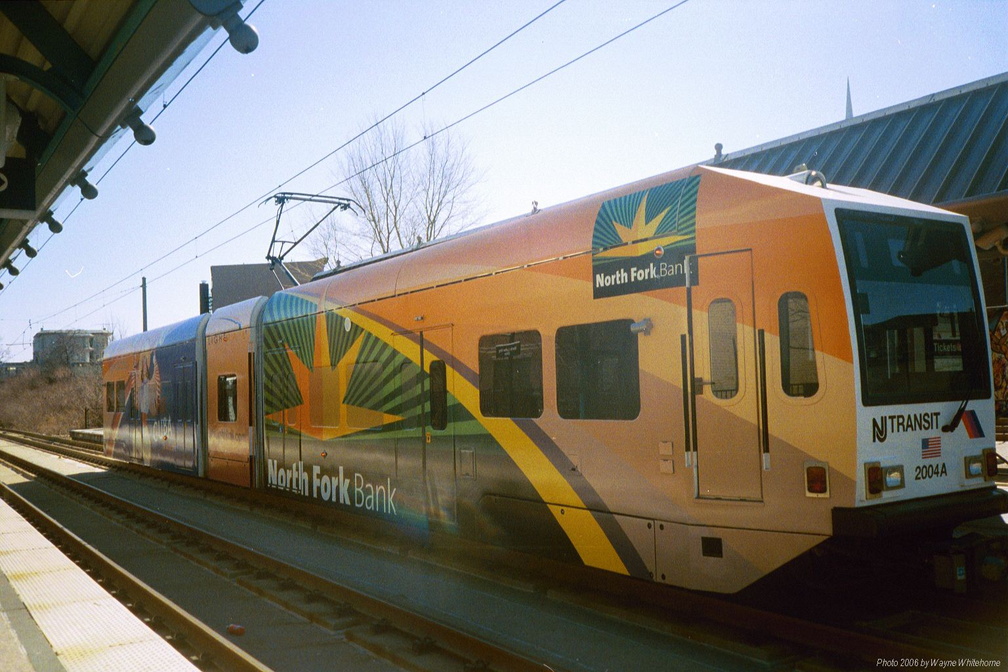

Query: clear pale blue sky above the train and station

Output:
[0, 0, 1008, 361]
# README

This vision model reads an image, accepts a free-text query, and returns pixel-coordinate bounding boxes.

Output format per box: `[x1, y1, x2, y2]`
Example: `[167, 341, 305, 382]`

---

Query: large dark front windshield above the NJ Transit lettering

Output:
[837, 210, 990, 406]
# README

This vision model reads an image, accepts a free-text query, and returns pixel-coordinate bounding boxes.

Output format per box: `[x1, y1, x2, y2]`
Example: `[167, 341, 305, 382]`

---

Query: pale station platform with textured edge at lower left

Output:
[0, 493, 198, 672]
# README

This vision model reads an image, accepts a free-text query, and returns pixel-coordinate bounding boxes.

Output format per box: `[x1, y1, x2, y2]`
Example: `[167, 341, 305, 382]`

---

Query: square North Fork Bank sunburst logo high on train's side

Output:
[592, 175, 700, 298]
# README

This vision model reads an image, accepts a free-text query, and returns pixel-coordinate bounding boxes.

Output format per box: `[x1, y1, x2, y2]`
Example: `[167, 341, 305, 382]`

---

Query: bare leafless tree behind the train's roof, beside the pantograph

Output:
[309, 116, 479, 264]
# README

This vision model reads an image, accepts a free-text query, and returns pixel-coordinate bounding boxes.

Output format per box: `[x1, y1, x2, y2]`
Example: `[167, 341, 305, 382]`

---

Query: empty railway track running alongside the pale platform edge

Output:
[3, 436, 542, 671]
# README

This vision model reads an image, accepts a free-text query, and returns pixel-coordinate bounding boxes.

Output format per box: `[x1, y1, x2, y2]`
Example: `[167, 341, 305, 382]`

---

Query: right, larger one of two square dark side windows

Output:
[556, 319, 640, 420]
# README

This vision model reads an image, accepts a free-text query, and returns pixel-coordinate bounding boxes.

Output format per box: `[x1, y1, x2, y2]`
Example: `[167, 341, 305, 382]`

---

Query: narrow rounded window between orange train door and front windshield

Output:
[777, 291, 818, 397]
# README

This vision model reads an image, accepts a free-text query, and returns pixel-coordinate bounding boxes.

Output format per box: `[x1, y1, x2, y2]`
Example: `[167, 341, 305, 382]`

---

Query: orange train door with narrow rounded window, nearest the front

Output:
[686, 250, 763, 501]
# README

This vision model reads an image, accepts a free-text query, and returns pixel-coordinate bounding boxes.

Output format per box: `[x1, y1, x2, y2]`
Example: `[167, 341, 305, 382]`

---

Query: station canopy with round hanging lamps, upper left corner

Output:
[0, 0, 258, 284]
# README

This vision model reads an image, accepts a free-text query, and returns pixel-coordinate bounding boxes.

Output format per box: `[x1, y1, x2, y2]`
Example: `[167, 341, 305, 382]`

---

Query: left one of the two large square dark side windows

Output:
[480, 330, 542, 418]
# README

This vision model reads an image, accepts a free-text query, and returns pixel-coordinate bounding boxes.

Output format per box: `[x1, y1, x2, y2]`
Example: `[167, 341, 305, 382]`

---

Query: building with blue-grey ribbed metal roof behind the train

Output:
[709, 73, 1008, 307]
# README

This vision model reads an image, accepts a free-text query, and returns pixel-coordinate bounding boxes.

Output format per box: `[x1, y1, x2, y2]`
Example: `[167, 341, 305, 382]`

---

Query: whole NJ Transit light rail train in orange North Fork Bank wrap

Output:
[104, 166, 1008, 592]
